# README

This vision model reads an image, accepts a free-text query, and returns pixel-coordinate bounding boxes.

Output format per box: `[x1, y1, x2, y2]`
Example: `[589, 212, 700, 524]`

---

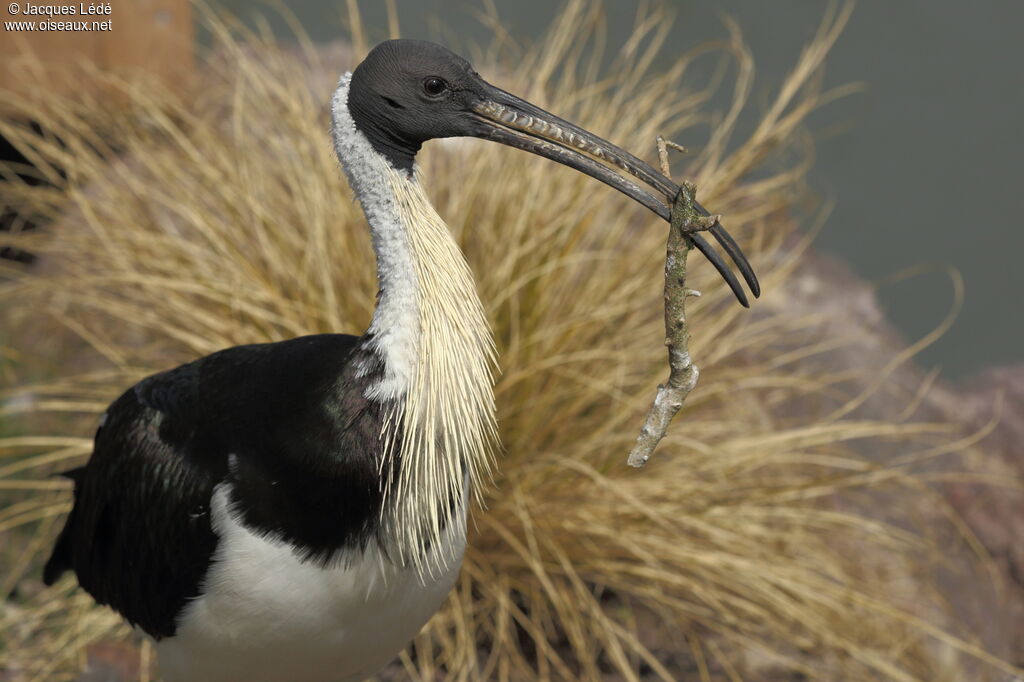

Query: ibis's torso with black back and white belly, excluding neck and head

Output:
[47, 335, 475, 682]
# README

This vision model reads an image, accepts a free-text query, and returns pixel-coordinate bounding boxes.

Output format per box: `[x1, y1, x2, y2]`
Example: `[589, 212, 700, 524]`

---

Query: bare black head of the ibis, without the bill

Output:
[348, 40, 489, 171]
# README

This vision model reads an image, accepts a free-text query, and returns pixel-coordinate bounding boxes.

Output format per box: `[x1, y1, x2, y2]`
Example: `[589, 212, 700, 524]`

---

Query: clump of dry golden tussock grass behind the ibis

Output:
[0, 2, 1010, 681]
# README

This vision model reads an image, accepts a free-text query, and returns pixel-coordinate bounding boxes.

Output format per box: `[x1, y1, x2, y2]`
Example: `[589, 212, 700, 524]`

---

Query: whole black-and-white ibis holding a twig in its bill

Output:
[44, 40, 757, 682]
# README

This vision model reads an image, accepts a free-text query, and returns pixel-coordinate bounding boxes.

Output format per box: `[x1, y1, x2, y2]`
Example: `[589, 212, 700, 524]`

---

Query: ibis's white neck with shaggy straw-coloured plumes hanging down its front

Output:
[333, 75, 497, 569]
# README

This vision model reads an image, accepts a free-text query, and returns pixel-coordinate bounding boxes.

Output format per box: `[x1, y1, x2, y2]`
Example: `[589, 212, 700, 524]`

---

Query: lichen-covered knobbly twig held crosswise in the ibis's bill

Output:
[627, 135, 719, 467]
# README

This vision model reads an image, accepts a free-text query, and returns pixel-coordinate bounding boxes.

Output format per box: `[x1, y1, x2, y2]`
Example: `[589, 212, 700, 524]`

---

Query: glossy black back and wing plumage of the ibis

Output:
[38, 335, 382, 639]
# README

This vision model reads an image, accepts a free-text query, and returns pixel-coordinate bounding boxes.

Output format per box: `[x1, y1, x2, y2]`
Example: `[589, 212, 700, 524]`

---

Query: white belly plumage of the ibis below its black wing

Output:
[158, 485, 466, 682]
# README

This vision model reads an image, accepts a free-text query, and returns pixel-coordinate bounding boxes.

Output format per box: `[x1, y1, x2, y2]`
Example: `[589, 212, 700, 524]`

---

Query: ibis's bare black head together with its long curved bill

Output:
[348, 40, 760, 305]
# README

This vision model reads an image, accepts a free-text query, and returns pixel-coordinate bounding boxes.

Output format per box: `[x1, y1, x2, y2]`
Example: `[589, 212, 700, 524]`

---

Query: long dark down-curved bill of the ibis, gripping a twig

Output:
[473, 84, 761, 307]
